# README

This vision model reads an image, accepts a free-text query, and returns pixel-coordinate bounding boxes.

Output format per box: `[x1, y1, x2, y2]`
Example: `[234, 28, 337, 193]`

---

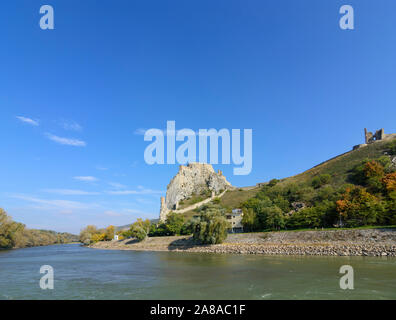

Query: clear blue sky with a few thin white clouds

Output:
[0, 0, 396, 233]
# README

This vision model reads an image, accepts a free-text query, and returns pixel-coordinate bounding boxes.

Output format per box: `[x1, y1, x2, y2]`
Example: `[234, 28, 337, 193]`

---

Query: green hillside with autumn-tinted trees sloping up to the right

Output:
[180, 138, 396, 230]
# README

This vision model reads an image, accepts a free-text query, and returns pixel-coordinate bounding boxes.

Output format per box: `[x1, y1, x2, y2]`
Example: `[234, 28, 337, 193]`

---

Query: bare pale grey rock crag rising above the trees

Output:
[160, 163, 231, 221]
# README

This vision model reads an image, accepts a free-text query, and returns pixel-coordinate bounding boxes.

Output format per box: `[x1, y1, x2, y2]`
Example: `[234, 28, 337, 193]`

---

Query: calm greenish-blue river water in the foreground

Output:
[0, 244, 396, 299]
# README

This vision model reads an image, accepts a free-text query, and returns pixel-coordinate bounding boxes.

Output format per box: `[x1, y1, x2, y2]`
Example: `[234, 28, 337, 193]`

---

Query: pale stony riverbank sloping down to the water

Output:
[90, 229, 396, 257]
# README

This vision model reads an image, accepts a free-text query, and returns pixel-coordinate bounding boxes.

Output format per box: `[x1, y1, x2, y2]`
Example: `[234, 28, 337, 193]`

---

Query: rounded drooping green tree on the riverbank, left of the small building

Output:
[194, 205, 231, 244]
